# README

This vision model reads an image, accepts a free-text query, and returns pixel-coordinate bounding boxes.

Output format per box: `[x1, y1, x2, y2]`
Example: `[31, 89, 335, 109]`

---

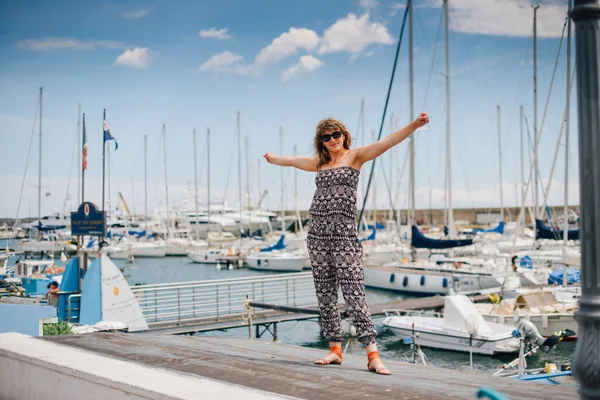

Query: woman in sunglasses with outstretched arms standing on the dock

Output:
[264, 113, 429, 375]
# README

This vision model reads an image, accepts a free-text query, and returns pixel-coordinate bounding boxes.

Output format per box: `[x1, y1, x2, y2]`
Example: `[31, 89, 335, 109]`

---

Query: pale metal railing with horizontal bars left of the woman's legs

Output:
[132, 272, 317, 326]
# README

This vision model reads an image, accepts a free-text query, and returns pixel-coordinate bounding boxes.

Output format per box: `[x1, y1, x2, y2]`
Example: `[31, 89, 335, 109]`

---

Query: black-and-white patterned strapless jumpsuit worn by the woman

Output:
[307, 167, 377, 347]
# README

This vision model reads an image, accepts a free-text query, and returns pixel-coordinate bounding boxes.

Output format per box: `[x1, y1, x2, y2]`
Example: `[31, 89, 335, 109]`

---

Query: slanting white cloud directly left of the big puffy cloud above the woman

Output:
[254, 28, 320, 66]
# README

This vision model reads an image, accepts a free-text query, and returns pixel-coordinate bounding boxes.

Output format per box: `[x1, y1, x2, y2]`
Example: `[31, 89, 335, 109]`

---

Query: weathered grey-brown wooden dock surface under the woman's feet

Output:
[39, 333, 577, 400]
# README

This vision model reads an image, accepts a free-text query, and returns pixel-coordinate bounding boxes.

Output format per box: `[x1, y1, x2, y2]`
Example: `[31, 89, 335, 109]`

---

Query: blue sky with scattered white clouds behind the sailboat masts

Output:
[0, 0, 578, 217]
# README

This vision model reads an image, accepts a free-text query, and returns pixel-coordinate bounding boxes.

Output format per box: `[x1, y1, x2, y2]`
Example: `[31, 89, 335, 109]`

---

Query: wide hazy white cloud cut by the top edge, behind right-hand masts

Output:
[450, 0, 567, 37]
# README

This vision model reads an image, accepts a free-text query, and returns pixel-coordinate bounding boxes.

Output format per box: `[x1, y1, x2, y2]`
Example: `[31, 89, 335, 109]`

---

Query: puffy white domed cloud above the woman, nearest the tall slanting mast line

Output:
[319, 13, 393, 54]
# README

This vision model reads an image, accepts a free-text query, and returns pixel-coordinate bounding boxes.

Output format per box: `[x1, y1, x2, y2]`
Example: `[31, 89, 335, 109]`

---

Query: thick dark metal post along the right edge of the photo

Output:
[570, 0, 600, 399]
